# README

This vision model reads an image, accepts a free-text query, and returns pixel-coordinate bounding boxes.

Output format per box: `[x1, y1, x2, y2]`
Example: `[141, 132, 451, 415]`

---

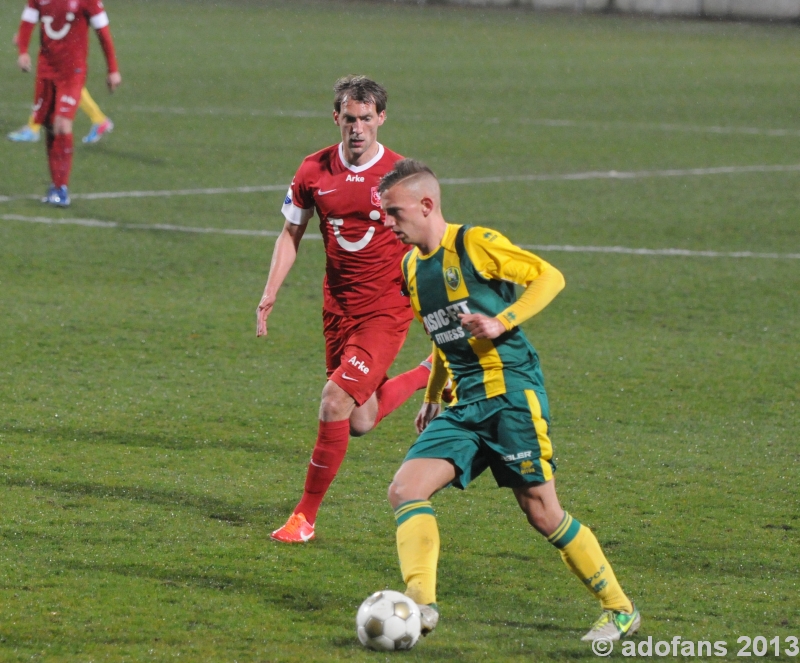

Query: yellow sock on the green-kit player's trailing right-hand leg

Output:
[547, 511, 633, 612]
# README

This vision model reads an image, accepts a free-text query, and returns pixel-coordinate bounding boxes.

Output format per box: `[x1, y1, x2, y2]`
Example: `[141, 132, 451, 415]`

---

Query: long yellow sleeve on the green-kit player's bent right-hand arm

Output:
[464, 228, 564, 330]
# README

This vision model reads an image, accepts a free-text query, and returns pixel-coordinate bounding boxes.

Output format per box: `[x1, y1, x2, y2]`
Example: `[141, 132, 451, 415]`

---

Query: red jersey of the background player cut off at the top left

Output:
[22, 0, 108, 80]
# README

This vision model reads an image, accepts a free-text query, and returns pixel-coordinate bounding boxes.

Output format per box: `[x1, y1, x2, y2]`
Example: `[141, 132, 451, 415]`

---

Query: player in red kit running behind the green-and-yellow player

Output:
[256, 76, 430, 543]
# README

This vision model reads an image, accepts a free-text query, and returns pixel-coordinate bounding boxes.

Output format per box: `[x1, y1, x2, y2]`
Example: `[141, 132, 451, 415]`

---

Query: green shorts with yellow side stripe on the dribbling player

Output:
[406, 389, 556, 490]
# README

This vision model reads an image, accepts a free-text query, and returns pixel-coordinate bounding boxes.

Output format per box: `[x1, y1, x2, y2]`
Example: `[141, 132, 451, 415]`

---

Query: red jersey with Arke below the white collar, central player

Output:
[281, 143, 409, 316]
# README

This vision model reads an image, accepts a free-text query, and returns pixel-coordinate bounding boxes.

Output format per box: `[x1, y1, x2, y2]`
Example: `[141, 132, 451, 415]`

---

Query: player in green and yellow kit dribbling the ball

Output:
[380, 159, 641, 640]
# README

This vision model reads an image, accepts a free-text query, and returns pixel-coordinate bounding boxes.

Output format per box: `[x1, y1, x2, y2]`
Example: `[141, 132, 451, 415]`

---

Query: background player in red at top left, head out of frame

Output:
[17, 0, 122, 207]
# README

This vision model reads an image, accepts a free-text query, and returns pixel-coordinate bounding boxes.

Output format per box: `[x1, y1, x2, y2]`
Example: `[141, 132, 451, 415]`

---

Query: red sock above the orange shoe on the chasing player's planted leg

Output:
[294, 419, 350, 525]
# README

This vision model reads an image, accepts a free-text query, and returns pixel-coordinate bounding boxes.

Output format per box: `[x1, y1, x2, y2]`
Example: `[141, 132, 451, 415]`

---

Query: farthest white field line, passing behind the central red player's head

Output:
[0, 102, 800, 138]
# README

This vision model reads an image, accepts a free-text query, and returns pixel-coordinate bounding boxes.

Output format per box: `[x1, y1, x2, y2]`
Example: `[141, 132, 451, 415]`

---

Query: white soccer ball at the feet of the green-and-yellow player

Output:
[356, 589, 422, 651]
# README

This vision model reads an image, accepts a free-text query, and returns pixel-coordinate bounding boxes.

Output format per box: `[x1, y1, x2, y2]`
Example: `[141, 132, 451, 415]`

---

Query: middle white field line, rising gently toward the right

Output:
[0, 164, 800, 203]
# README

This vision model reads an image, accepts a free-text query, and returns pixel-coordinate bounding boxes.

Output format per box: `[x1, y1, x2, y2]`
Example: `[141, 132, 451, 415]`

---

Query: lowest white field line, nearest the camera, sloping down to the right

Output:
[0, 214, 800, 260]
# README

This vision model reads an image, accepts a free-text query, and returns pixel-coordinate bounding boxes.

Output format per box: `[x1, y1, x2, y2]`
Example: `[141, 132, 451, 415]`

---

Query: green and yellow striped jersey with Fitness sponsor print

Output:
[402, 224, 563, 403]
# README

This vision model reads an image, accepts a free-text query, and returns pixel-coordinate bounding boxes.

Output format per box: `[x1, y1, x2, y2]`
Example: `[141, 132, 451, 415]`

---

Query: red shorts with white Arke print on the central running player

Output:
[322, 306, 414, 405]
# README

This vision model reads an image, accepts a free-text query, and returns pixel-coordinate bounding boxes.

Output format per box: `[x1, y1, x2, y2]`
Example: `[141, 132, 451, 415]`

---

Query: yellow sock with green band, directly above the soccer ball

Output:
[394, 500, 439, 605]
